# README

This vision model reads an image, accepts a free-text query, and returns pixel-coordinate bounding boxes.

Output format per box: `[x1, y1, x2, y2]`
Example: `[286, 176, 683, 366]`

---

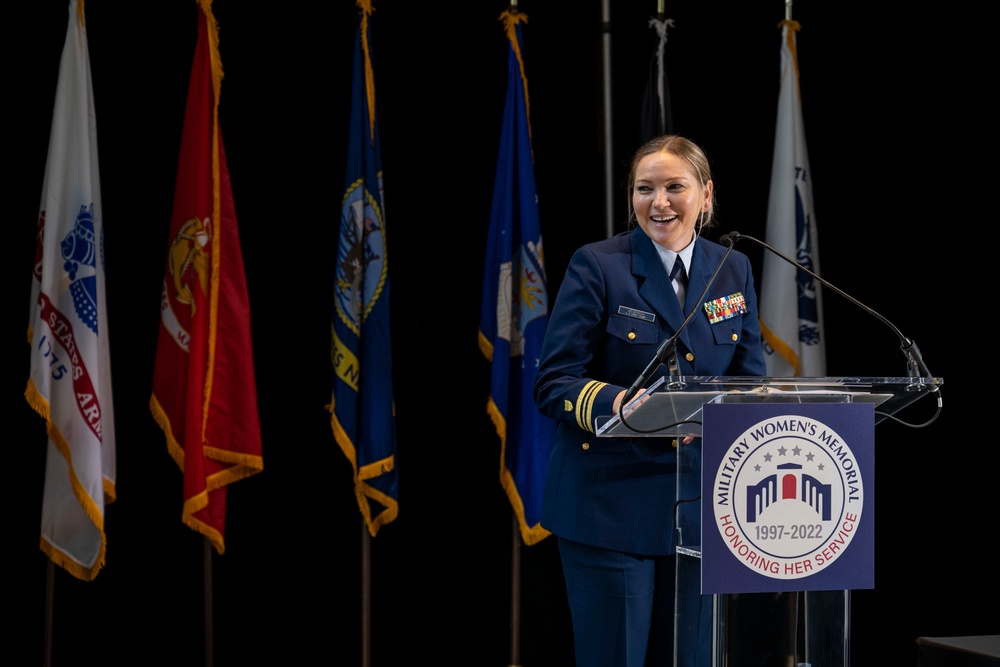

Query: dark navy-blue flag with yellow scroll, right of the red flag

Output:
[328, 0, 399, 537]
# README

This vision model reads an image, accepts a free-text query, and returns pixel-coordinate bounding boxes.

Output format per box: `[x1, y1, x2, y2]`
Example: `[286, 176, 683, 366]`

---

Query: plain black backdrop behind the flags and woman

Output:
[11, 0, 1000, 667]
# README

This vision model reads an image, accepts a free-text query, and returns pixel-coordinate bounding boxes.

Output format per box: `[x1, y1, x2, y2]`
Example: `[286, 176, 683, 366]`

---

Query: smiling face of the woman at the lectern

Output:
[631, 150, 712, 252]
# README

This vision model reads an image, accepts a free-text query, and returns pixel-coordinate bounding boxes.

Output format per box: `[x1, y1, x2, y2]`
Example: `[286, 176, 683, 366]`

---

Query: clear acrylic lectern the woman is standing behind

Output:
[596, 376, 943, 667]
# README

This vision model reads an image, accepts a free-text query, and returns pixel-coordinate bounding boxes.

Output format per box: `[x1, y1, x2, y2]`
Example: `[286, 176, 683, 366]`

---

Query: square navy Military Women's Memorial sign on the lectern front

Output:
[701, 397, 875, 594]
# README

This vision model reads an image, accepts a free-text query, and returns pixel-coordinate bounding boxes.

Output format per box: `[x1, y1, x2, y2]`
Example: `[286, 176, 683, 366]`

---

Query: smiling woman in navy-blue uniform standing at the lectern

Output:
[534, 135, 765, 667]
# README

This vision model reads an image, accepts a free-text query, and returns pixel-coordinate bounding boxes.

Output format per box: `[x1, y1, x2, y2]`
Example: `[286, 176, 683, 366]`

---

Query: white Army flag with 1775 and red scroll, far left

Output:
[25, 0, 115, 581]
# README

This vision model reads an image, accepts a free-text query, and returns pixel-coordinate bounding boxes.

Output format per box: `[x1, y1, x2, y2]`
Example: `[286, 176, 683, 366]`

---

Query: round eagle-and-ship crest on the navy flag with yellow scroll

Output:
[335, 175, 388, 335]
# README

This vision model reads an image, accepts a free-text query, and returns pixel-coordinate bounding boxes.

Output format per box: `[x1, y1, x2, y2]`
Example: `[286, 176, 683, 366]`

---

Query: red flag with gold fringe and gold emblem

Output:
[150, 0, 264, 554]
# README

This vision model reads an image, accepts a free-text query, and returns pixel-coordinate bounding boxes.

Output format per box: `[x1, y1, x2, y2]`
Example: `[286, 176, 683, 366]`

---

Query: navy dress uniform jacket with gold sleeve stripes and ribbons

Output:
[534, 227, 766, 556]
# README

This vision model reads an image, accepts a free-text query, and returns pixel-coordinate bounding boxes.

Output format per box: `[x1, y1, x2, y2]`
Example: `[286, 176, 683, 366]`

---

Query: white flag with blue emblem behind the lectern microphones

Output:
[760, 20, 826, 377]
